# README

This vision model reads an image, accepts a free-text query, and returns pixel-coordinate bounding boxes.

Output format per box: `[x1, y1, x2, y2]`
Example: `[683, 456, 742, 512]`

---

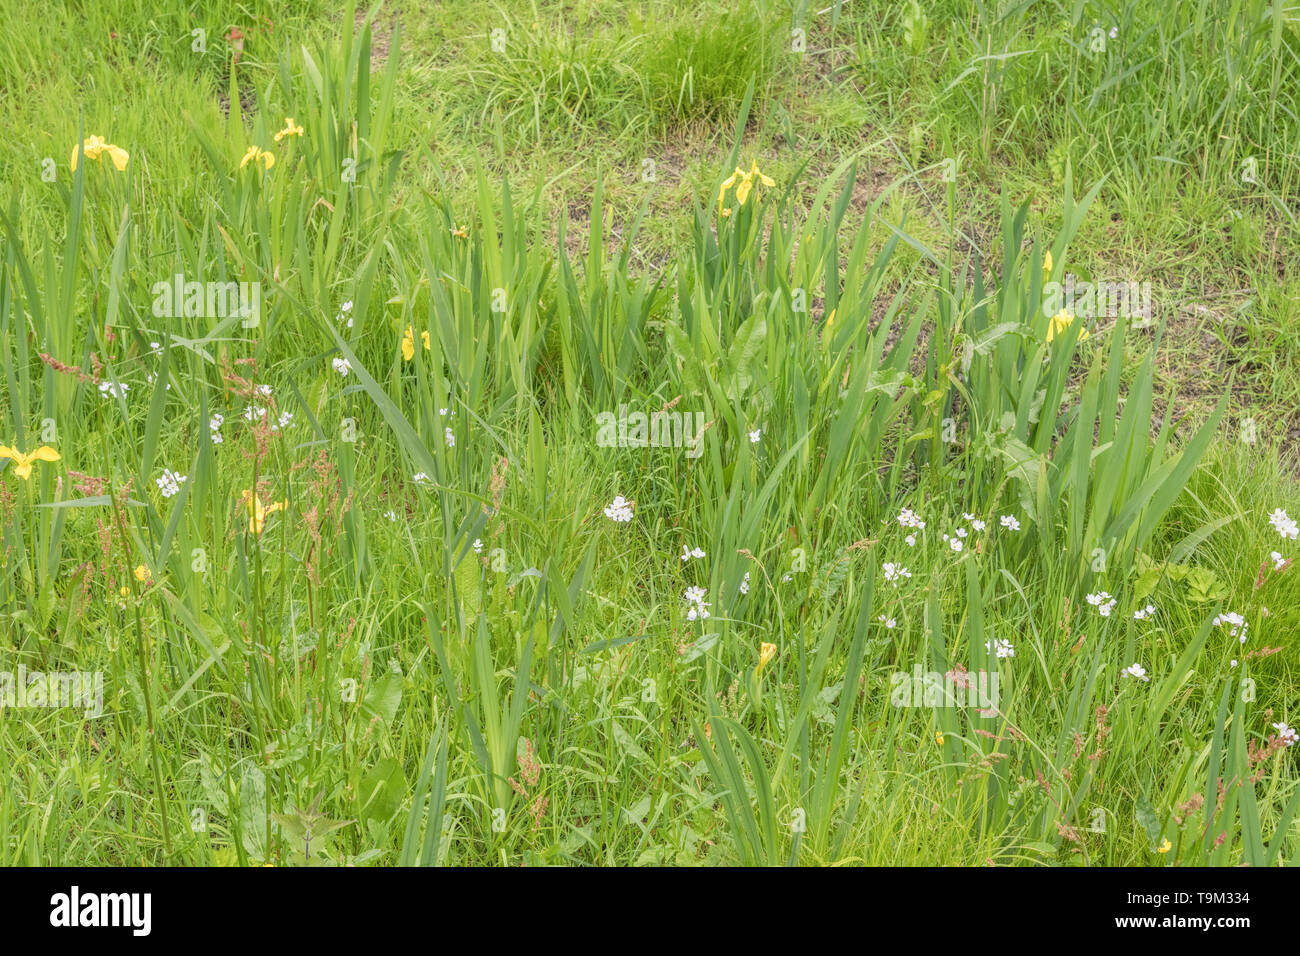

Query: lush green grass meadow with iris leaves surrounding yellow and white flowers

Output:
[0, 0, 1300, 866]
